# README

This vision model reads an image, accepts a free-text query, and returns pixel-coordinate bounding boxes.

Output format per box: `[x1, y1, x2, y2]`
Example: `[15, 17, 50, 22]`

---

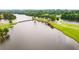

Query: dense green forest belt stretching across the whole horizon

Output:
[0, 9, 79, 21]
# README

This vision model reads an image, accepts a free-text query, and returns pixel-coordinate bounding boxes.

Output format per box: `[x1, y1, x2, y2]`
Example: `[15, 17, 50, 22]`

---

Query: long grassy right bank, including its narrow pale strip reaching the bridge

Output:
[35, 18, 79, 42]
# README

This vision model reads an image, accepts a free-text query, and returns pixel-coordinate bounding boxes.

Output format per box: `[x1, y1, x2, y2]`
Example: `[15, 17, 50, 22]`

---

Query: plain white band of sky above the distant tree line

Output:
[0, 0, 79, 9]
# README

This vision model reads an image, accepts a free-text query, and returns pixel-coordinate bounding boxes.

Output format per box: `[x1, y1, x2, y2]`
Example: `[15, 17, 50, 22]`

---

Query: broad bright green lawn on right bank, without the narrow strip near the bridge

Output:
[50, 22, 79, 42]
